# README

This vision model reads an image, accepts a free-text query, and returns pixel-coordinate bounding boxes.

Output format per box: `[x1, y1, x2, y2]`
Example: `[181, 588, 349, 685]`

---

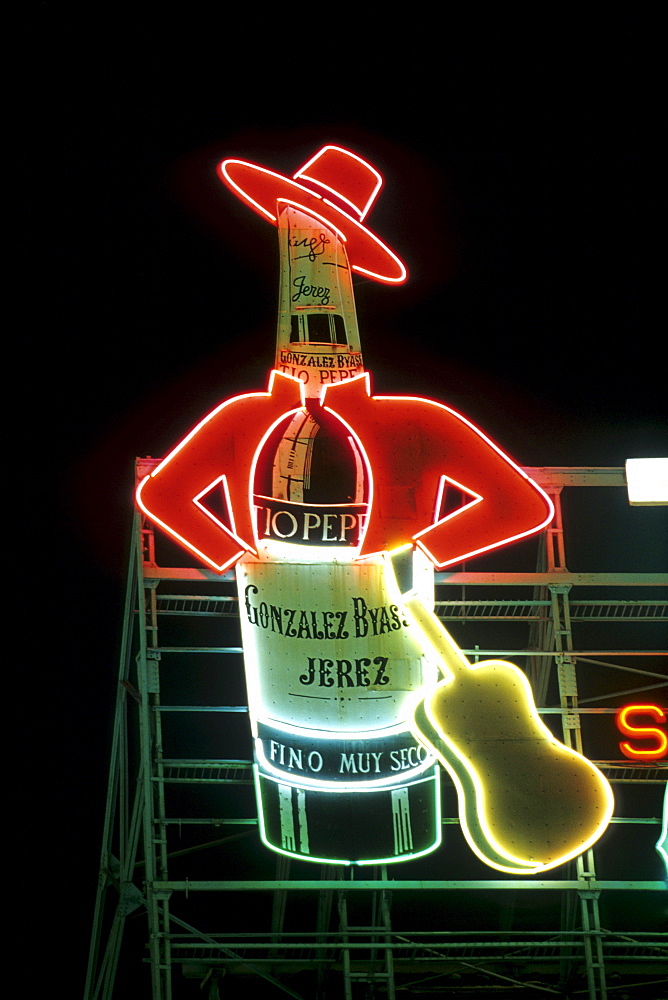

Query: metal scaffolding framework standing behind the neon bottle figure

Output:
[85, 468, 668, 1000]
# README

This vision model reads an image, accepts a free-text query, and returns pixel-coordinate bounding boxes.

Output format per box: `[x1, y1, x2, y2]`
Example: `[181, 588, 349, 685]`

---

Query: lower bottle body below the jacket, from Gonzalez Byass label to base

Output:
[236, 541, 441, 864]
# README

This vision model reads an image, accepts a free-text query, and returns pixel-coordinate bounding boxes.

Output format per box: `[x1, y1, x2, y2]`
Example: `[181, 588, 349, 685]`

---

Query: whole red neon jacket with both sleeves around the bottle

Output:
[137, 372, 553, 572]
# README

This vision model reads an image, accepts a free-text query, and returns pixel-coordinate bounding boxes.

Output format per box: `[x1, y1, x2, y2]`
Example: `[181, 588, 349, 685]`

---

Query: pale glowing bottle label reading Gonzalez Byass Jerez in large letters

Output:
[237, 549, 436, 736]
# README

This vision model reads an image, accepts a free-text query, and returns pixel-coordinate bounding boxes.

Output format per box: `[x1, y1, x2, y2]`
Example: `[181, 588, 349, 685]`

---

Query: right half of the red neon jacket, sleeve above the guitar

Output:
[326, 379, 553, 567]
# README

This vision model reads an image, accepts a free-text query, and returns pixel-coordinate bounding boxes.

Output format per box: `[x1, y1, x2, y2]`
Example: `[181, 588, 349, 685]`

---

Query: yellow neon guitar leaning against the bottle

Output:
[406, 598, 614, 875]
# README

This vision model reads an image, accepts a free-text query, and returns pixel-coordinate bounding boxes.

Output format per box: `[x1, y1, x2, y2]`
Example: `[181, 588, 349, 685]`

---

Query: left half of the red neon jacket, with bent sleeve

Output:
[137, 372, 301, 573]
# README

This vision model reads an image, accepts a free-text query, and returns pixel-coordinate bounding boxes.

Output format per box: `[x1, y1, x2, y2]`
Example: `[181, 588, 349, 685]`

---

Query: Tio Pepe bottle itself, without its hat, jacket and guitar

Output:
[236, 205, 441, 864]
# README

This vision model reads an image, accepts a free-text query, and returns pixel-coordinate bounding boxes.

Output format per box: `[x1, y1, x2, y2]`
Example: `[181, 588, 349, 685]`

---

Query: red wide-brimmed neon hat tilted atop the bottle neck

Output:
[218, 146, 406, 284]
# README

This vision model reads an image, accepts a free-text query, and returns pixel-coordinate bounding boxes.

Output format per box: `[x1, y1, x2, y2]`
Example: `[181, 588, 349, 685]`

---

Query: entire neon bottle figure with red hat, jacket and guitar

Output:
[137, 145, 612, 874]
